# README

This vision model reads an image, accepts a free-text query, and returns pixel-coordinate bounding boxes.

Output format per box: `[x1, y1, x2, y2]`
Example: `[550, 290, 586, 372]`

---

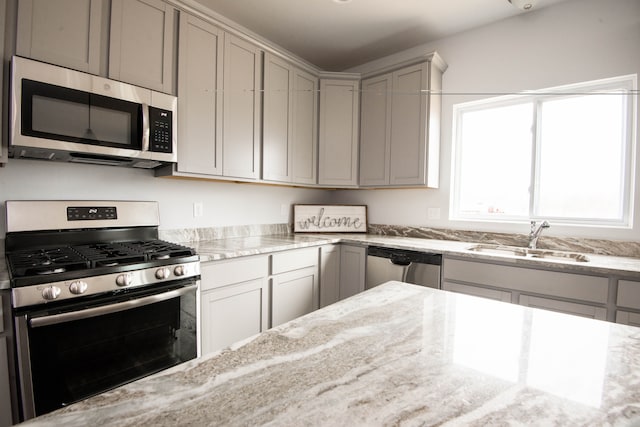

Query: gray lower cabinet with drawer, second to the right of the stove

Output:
[271, 247, 320, 327]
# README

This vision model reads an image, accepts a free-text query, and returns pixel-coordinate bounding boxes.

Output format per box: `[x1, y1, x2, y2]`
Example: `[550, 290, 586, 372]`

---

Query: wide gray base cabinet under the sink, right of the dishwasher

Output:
[442, 257, 613, 320]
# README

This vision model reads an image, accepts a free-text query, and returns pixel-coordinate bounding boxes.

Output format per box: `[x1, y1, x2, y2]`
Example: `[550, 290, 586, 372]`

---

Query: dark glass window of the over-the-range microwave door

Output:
[22, 79, 142, 150]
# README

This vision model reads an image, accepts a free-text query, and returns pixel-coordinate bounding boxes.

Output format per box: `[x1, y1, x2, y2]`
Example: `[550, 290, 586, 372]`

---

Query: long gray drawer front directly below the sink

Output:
[443, 258, 609, 304]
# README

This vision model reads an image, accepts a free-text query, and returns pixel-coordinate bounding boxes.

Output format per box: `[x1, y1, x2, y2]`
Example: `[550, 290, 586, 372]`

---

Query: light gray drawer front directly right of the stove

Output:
[201, 256, 269, 291]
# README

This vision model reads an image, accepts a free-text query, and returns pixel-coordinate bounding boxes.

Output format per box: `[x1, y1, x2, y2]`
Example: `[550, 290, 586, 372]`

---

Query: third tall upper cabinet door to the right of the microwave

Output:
[262, 54, 293, 182]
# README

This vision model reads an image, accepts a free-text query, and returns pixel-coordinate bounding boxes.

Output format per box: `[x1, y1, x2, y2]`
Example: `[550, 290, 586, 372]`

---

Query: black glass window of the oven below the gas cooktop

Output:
[29, 291, 196, 415]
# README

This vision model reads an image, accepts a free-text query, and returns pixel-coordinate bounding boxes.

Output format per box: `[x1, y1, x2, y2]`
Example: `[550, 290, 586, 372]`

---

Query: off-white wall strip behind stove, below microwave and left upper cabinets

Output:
[0, 159, 329, 237]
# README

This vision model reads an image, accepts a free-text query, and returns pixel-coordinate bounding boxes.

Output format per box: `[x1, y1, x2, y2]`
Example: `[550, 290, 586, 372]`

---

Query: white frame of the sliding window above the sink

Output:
[449, 74, 638, 228]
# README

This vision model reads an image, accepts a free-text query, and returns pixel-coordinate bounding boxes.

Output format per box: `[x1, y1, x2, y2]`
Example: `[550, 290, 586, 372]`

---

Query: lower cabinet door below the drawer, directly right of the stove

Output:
[200, 279, 269, 355]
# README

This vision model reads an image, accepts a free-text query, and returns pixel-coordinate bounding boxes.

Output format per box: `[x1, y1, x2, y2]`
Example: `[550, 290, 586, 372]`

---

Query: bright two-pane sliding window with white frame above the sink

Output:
[451, 76, 637, 226]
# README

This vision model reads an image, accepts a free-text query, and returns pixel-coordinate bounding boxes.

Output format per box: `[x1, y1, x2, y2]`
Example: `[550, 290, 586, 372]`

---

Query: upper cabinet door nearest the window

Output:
[389, 64, 429, 185]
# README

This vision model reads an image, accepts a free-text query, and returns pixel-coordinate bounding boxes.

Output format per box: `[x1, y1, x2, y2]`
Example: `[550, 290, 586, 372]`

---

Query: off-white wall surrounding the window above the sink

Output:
[334, 0, 640, 240]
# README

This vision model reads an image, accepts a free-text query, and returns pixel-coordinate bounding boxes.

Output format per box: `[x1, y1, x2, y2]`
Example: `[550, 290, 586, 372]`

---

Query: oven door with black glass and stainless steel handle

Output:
[15, 280, 199, 419]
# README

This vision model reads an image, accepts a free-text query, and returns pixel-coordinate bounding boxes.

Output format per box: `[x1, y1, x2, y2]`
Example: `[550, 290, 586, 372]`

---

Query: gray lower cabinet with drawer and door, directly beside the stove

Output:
[200, 256, 269, 355]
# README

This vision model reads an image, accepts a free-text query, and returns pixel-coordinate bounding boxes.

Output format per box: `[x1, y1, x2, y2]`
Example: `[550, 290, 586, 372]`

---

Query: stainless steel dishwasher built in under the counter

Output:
[365, 246, 442, 289]
